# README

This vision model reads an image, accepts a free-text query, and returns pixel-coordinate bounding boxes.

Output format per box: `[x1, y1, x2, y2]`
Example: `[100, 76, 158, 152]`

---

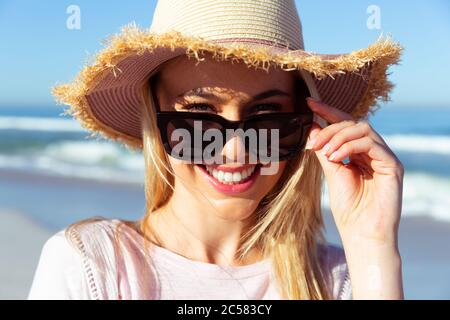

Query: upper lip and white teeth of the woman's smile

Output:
[197, 164, 261, 185]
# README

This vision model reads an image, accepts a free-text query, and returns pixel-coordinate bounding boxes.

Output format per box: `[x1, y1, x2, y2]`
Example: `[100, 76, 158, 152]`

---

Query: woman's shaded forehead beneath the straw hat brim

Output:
[154, 55, 294, 95]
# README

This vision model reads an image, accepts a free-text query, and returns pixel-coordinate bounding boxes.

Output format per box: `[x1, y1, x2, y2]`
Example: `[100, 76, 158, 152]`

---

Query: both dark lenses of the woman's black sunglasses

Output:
[160, 114, 309, 162]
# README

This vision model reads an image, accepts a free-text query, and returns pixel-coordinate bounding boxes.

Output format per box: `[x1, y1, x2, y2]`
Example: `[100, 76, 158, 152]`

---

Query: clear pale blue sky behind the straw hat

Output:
[0, 0, 450, 108]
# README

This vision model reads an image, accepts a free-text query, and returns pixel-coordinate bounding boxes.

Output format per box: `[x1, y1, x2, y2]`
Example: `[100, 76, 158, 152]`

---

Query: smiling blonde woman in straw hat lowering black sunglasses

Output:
[29, 0, 403, 299]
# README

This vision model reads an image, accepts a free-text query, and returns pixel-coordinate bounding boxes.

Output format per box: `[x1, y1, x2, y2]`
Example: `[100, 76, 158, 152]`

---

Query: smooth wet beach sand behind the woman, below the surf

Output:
[0, 170, 450, 299]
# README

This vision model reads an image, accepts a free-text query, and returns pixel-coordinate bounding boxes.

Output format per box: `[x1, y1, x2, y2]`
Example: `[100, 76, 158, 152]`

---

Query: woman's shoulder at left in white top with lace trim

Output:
[28, 219, 126, 299]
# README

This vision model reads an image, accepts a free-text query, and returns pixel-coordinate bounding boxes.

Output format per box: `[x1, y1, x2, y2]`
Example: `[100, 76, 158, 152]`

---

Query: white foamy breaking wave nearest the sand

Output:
[0, 141, 450, 221]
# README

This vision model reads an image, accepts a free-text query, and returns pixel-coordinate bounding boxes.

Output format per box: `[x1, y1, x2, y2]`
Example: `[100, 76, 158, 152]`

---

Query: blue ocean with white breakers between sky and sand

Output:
[0, 106, 450, 221]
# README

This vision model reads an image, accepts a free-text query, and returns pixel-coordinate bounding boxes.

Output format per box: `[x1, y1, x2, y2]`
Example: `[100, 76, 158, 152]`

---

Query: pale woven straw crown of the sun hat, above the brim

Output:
[150, 0, 304, 50]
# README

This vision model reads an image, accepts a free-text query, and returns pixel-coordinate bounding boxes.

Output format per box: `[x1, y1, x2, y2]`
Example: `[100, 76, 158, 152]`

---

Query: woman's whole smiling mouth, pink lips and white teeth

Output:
[196, 164, 261, 194]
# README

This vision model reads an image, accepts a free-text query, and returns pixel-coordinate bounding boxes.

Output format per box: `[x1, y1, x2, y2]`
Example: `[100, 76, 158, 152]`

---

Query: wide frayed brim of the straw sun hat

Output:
[52, 25, 402, 149]
